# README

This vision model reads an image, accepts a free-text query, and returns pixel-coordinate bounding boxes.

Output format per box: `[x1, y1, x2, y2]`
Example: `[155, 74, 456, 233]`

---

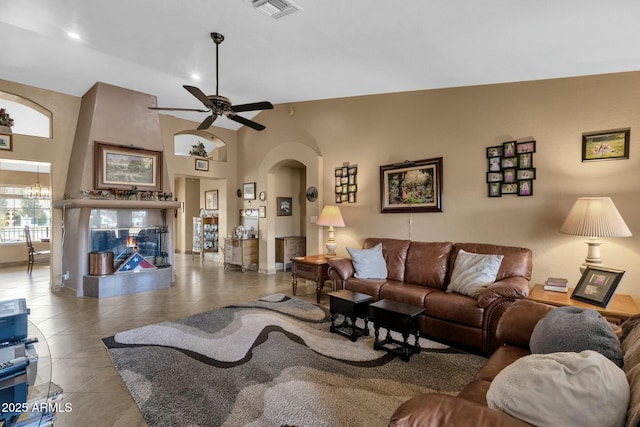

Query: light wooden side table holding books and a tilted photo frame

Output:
[529, 284, 640, 325]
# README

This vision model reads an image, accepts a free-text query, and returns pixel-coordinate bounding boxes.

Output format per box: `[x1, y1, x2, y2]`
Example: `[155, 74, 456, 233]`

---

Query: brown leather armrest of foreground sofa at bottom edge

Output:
[389, 393, 530, 427]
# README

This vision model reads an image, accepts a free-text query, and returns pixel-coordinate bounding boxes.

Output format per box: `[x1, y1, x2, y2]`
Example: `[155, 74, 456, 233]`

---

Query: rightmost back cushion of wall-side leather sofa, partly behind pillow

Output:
[447, 243, 533, 281]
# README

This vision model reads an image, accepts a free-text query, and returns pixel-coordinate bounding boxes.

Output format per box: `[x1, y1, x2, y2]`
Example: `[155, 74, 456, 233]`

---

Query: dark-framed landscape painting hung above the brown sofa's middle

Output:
[380, 157, 443, 213]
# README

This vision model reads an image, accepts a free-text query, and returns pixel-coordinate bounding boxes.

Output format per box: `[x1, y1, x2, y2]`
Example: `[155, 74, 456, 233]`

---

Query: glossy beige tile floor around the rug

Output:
[0, 255, 328, 427]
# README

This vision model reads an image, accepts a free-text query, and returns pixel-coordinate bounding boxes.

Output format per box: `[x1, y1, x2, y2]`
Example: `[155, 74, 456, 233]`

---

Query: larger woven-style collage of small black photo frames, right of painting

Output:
[487, 141, 536, 197]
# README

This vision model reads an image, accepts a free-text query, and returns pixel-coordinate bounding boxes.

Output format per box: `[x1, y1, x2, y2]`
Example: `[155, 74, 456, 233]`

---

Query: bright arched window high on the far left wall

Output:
[0, 91, 51, 138]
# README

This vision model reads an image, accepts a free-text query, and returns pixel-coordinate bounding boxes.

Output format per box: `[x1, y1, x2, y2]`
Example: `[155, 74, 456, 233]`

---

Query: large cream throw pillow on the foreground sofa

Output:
[487, 350, 630, 427]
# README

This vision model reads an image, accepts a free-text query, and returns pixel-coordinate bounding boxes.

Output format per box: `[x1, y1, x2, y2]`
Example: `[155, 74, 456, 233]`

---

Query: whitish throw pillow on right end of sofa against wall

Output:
[447, 249, 504, 298]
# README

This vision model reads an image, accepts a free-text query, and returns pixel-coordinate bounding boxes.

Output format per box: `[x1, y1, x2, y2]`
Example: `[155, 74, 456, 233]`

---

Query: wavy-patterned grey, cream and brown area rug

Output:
[103, 294, 485, 426]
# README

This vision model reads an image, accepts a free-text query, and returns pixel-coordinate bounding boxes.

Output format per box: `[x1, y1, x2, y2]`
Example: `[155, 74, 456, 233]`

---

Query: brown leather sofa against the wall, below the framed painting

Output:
[329, 238, 532, 354]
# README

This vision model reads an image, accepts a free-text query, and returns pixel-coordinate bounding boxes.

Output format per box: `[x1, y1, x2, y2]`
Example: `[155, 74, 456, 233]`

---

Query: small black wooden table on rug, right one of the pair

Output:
[369, 299, 424, 362]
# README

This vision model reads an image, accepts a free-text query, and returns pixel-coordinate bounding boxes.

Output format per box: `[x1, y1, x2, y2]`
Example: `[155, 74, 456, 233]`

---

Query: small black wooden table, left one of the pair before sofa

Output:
[327, 289, 371, 342]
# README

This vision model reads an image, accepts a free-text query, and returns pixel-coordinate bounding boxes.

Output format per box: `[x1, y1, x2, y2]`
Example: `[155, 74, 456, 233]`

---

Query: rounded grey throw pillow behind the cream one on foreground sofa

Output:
[529, 306, 623, 367]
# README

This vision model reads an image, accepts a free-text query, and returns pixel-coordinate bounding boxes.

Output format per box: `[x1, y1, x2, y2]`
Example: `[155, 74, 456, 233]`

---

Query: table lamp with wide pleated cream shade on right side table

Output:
[560, 197, 631, 272]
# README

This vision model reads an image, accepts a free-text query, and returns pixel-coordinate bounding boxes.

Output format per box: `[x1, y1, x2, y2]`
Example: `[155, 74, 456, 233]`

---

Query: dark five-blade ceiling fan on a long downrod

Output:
[149, 33, 273, 131]
